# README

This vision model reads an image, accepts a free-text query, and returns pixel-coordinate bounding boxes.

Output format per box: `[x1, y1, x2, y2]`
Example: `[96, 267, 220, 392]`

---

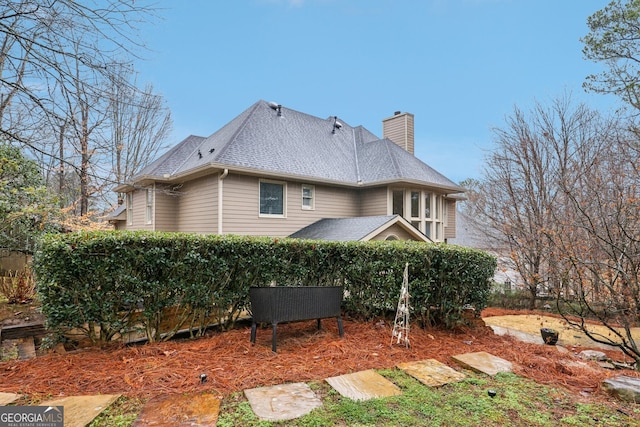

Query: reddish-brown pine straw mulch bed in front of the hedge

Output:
[0, 310, 640, 399]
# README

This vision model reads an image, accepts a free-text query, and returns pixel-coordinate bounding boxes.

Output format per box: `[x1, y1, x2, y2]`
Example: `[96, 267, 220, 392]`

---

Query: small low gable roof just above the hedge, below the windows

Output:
[289, 215, 429, 242]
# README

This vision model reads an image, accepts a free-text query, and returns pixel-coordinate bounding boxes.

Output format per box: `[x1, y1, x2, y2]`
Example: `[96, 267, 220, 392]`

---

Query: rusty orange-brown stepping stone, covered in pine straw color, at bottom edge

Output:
[133, 394, 221, 427]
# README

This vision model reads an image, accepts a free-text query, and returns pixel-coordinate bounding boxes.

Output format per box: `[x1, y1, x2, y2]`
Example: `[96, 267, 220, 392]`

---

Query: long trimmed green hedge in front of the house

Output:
[33, 231, 496, 342]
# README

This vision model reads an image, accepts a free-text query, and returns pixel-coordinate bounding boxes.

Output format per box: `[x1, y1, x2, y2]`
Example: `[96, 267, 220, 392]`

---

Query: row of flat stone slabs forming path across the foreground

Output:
[0, 352, 640, 427]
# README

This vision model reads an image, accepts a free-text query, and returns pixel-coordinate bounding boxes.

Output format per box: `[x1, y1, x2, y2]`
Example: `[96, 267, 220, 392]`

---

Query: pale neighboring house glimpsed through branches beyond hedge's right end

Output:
[449, 211, 523, 291]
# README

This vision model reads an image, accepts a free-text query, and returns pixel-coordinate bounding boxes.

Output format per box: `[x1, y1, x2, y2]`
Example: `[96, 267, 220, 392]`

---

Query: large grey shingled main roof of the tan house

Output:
[133, 101, 464, 193]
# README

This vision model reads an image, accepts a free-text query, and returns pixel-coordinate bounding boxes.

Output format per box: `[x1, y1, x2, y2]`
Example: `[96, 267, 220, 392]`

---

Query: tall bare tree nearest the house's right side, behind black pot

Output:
[474, 96, 598, 308]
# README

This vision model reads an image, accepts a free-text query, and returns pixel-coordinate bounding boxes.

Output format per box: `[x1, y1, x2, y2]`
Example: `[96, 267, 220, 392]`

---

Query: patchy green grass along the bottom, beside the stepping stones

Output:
[86, 369, 640, 427]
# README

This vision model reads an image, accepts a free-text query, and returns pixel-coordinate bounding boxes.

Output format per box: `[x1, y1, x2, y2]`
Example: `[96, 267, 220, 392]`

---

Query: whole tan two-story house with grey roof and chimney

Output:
[110, 101, 464, 242]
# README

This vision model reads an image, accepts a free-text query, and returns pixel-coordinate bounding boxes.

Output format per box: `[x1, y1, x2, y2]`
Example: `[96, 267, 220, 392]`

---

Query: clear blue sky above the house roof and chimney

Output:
[136, 0, 615, 182]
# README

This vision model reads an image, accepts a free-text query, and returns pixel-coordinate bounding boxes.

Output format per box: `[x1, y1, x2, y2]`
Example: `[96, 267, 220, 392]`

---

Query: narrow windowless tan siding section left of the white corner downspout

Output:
[177, 174, 219, 234]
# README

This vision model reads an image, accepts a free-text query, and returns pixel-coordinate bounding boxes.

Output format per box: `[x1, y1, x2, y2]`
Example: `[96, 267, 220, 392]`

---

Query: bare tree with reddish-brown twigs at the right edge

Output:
[552, 128, 640, 369]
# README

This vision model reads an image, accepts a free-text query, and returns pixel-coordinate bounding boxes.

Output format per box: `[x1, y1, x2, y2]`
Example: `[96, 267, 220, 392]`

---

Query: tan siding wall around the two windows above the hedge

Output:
[223, 173, 358, 237]
